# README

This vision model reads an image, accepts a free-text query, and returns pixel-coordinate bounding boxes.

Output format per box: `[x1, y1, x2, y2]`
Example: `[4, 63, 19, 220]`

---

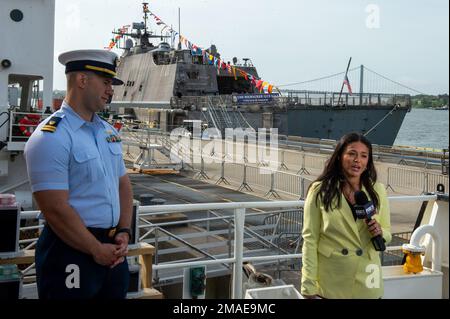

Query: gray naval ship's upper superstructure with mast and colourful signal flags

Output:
[114, 3, 258, 102]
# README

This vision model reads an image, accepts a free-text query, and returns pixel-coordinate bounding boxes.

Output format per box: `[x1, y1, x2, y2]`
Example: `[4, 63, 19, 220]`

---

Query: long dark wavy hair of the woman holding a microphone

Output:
[316, 133, 379, 212]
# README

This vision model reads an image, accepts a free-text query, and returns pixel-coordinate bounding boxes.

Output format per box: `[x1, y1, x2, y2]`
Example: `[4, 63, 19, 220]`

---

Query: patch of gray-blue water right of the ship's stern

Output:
[394, 109, 449, 149]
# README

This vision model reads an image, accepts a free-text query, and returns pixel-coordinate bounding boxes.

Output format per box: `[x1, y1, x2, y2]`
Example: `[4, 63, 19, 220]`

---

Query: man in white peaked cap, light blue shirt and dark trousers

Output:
[25, 50, 133, 299]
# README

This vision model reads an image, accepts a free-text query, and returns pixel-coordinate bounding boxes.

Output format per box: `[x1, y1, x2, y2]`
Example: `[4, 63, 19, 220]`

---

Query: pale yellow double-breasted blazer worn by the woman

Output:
[301, 182, 392, 299]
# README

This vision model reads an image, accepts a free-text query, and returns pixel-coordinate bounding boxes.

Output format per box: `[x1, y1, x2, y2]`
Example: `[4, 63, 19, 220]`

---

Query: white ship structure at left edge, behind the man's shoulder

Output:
[0, 0, 55, 207]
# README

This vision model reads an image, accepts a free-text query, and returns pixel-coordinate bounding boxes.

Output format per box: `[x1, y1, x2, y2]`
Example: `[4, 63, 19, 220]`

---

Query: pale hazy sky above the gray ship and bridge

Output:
[54, 0, 449, 94]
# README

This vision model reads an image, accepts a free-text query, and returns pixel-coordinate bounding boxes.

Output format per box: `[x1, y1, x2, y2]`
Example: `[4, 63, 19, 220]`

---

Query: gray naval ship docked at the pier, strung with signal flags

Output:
[111, 3, 411, 146]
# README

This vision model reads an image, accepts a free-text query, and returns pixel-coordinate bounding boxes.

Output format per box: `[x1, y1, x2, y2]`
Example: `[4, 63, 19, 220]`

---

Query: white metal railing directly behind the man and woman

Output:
[14, 195, 437, 299]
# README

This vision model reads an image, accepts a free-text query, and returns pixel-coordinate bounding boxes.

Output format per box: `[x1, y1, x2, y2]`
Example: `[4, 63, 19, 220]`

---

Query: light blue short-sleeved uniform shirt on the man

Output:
[25, 101, 126, 228]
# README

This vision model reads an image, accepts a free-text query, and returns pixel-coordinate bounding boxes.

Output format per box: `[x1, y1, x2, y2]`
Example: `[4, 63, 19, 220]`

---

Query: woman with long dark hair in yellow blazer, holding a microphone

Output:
[301, 133, 392, 298]
